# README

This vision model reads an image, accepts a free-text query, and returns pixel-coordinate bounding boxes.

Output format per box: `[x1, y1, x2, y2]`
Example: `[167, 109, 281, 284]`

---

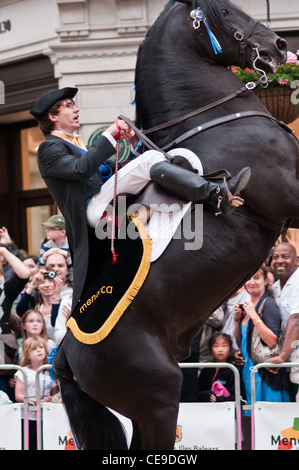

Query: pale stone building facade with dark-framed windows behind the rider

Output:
[0, 0, 299, 253]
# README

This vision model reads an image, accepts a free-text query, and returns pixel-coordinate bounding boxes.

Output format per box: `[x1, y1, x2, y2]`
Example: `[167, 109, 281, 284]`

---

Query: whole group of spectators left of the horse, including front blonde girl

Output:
[0, 215, 73, 449]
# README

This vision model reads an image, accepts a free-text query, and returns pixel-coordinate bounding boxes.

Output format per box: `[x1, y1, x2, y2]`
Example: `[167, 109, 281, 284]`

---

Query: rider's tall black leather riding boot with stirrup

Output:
[150, 161, 251, 214]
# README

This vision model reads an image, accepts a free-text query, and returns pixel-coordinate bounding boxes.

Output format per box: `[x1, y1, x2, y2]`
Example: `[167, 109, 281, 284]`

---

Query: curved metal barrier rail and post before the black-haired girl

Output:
[179, 362, 242, 450]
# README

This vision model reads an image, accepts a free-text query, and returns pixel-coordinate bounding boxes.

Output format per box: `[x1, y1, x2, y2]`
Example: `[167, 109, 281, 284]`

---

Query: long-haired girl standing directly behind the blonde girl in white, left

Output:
[18, 309, 57, 360]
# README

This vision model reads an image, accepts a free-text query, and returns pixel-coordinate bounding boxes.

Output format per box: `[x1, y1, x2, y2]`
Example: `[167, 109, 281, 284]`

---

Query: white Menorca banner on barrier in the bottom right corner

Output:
[254, 402, 299, 450]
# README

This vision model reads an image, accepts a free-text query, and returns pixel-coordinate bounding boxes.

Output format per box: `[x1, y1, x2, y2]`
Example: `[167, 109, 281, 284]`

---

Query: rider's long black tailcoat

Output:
[38, 135, 115, 306]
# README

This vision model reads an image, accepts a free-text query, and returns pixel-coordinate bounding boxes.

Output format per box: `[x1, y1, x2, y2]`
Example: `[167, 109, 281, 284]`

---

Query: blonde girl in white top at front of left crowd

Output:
[15, 336, 58, 450]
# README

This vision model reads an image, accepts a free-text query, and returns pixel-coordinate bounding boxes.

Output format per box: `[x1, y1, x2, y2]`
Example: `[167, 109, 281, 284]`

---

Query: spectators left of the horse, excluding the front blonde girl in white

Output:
[0, 220, 73, 392]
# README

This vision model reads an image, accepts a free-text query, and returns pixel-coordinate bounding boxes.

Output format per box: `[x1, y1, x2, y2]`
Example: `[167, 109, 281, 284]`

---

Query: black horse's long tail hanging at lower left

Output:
[54, 348, 128, 450]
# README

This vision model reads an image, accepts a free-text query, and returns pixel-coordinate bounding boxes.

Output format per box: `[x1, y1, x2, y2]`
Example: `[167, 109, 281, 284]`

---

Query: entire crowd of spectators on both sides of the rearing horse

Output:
[0, 215, 299, 450]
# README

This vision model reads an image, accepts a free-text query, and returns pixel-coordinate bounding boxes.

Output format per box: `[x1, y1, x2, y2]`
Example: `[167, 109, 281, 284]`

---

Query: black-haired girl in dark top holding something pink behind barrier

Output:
[198, 332, 235, 402]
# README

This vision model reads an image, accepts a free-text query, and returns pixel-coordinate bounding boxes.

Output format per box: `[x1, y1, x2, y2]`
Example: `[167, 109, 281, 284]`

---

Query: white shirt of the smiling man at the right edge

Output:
[272, 268, 299, 327]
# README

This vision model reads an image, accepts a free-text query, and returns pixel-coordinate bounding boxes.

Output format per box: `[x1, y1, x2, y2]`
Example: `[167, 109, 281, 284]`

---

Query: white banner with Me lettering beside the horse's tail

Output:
[42, 403, 77, 450]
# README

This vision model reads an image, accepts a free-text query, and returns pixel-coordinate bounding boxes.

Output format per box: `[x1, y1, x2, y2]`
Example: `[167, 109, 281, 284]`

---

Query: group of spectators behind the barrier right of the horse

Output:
[181, 242, 299, 449]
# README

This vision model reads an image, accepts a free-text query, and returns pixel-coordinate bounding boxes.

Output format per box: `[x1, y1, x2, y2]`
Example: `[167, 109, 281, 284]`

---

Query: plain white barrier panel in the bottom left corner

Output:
[0, 403, 22, 450]
